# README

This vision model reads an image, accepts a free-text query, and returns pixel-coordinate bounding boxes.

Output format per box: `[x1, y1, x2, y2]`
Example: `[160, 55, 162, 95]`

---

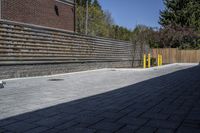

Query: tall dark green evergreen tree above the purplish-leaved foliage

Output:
[159, 0, 200, 30]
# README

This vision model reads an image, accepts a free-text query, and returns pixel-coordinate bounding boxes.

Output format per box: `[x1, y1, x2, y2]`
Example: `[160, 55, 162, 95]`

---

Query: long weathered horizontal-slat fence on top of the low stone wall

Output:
[0, 21, 139, 64]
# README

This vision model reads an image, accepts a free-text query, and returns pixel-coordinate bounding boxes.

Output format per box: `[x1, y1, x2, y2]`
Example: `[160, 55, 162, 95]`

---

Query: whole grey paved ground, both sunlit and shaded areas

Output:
[0, 65, 200, 133]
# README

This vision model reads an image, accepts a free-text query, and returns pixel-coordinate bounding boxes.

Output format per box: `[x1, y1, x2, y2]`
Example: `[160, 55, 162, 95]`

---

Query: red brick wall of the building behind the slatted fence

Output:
[2, 0, 75, 31]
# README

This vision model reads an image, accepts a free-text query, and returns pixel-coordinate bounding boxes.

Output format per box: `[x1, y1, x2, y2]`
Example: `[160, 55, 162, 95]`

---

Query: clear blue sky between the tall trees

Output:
[99, 0, 164, 29]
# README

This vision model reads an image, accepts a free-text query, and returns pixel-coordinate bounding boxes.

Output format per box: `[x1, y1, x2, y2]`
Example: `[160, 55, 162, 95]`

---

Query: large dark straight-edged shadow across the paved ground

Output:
[0, 66, 200, 133]
